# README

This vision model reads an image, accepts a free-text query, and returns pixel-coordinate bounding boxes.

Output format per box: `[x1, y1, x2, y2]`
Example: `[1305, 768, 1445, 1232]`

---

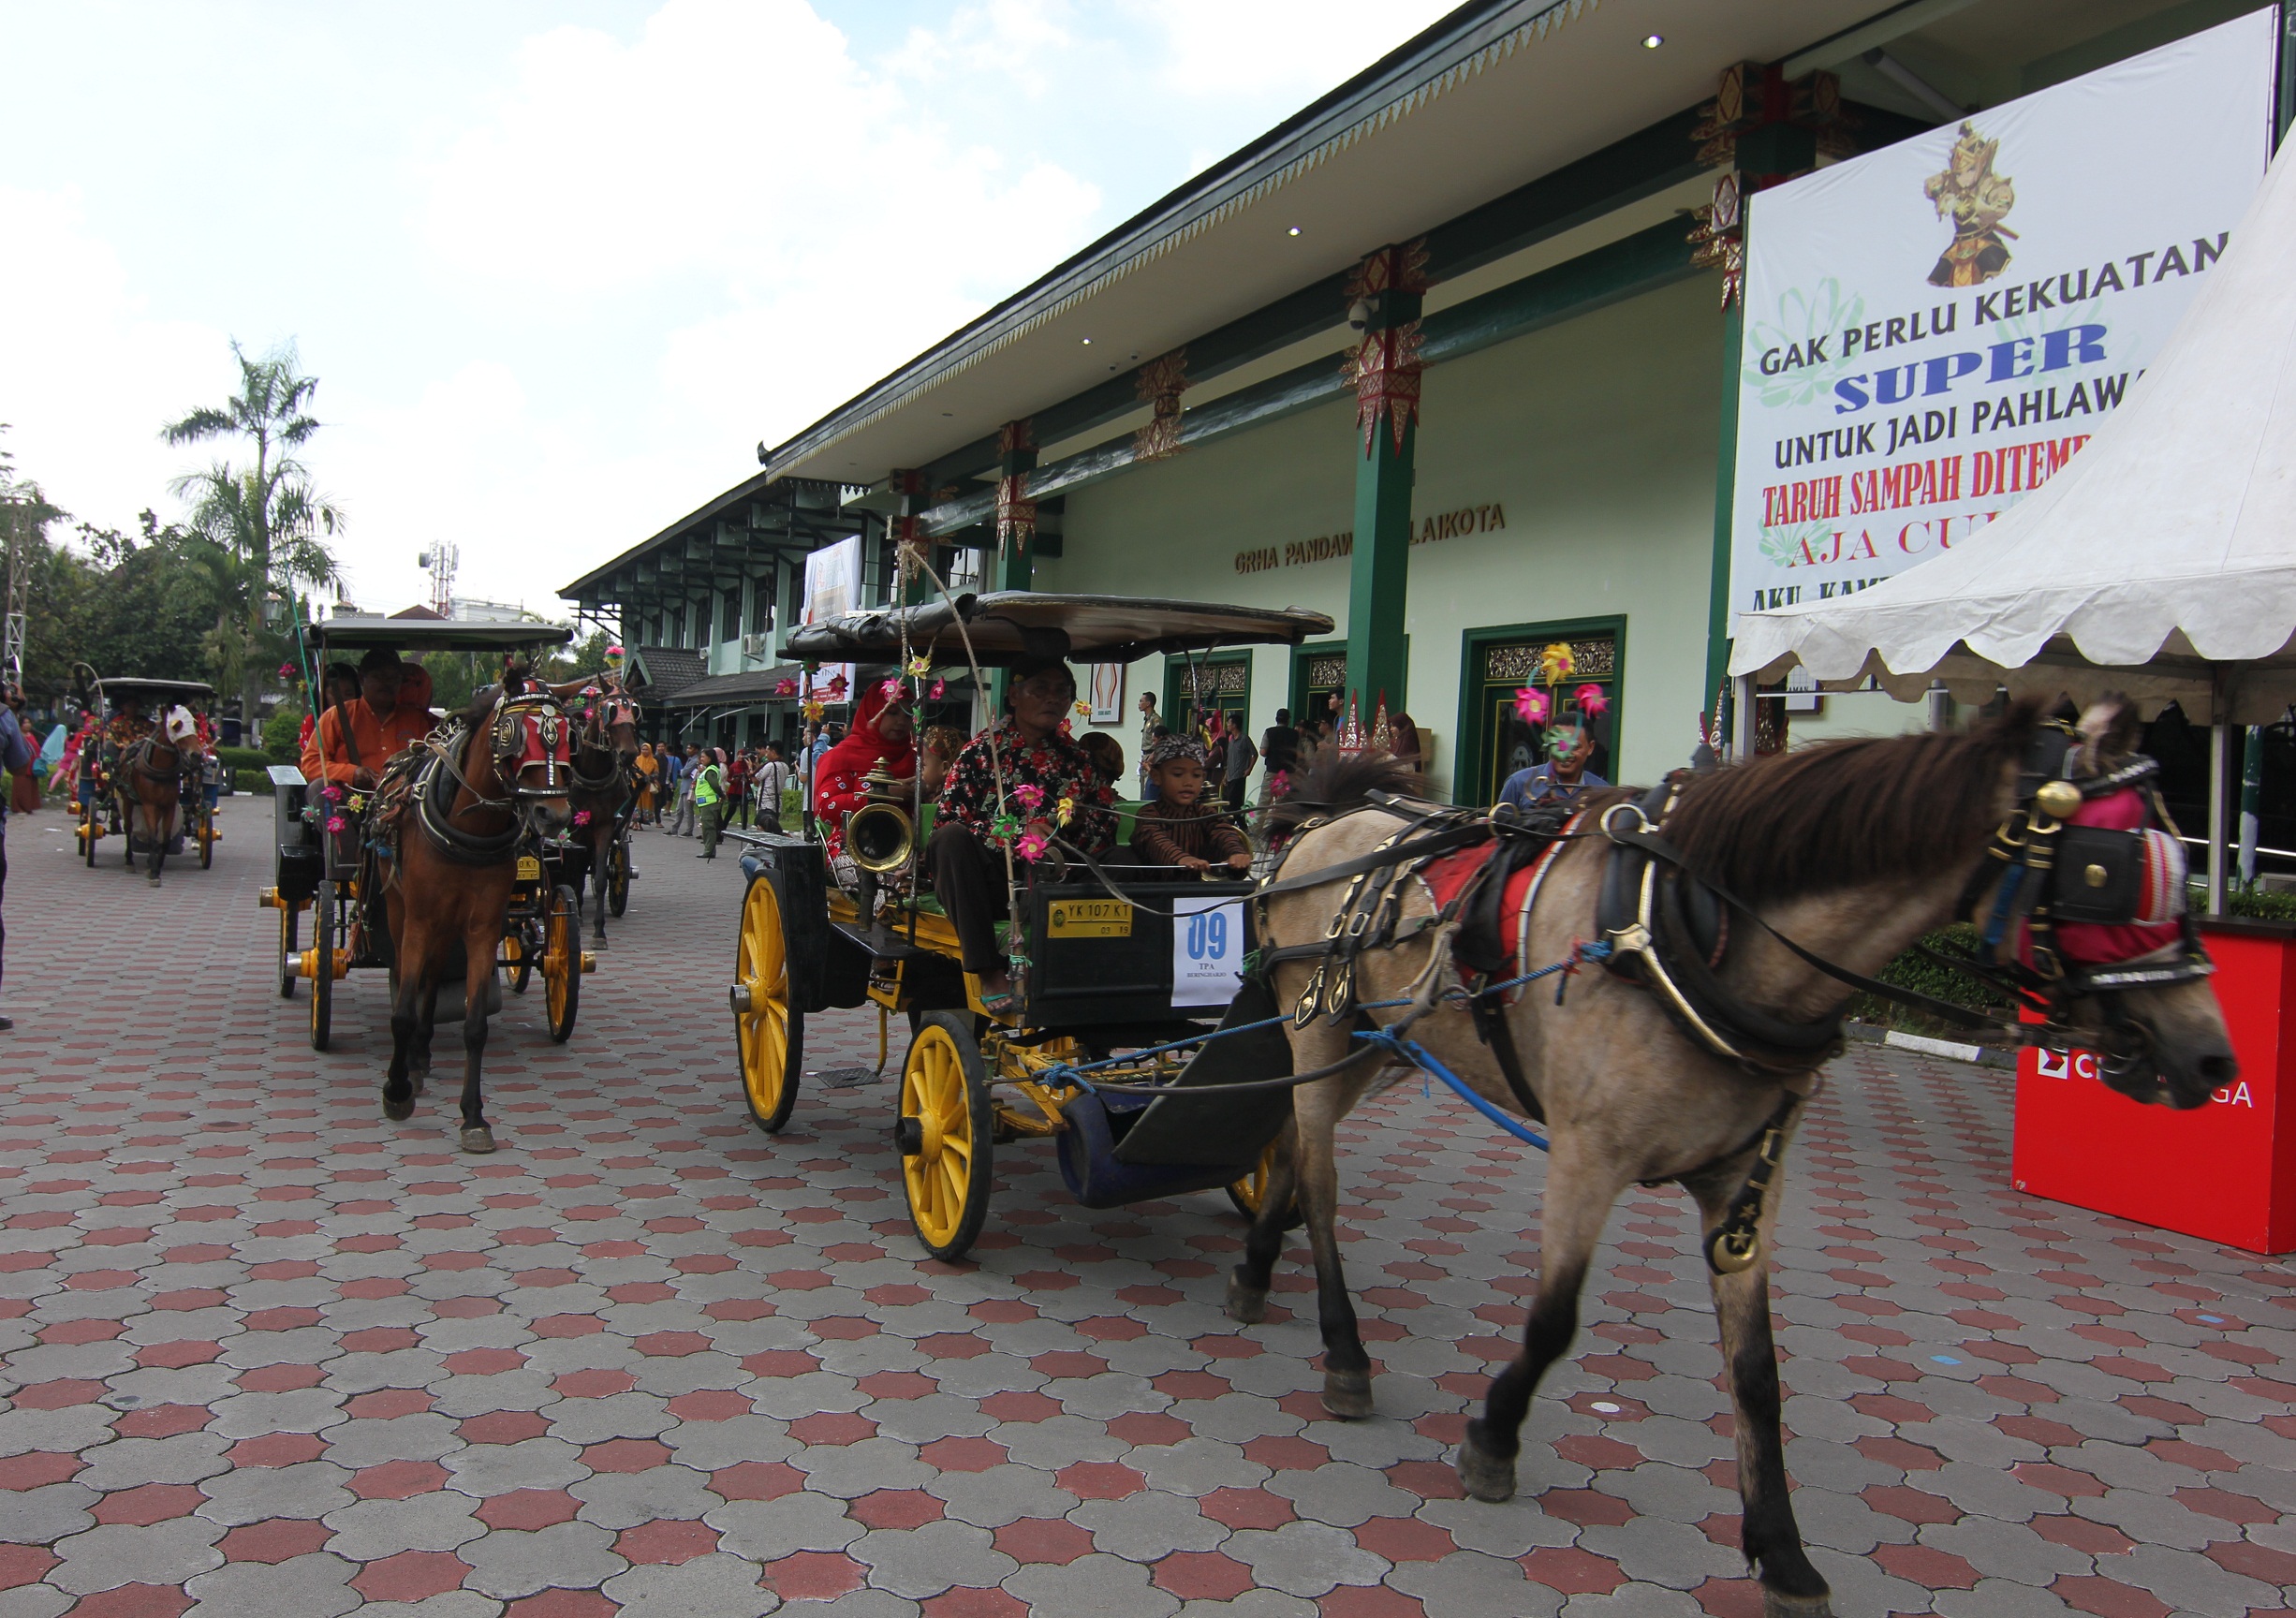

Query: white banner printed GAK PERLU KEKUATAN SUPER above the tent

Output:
[1731, 9, 2273, 612]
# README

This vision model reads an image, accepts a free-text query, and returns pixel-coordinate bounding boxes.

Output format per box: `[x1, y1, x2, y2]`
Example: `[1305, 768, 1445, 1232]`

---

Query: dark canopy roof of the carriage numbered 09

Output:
[781, 590, 1332, 668]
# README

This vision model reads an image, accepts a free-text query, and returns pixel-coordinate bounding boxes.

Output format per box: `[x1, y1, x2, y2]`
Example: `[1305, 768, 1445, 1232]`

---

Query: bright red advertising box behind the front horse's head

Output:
[2011, 920, 2296, 1253]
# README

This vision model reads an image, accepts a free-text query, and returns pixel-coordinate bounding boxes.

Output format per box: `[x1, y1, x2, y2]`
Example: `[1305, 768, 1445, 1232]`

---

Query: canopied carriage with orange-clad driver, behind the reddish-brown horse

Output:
[259, 620, 595, 1052]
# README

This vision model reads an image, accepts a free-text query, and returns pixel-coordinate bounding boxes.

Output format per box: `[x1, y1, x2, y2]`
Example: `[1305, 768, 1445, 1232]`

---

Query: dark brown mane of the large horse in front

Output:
[1667, 702, 2041, 900]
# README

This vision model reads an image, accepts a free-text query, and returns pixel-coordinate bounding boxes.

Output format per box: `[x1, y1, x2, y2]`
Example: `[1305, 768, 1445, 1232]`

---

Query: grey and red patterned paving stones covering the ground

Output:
[0, 799, 2296, 1618]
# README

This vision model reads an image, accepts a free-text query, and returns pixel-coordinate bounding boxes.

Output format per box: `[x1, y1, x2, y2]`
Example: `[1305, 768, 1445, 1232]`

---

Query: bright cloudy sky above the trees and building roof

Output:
[0, 0, 1449, 610]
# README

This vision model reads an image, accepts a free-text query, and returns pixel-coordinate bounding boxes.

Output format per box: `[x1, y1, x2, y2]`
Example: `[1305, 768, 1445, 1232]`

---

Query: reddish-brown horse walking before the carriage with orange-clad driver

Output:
[383, 691, 572, 1152]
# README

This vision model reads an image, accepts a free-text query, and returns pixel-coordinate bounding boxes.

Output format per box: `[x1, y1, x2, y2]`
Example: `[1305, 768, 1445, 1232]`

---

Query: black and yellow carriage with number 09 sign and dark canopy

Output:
[728, 592, 1332, 1258]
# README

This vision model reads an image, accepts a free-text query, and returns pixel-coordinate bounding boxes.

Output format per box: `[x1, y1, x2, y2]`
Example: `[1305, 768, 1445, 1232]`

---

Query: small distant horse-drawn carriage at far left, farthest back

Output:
[73, 670, 220, 881]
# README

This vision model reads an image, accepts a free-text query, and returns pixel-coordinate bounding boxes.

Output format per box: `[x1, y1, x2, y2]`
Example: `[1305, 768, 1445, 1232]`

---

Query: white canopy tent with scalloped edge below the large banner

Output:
[1729, 132, 2296, 909]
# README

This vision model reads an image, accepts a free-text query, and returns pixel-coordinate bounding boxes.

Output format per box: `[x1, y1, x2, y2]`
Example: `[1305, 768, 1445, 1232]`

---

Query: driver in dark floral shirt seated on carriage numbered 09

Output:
[928, 658, 1116, 1012]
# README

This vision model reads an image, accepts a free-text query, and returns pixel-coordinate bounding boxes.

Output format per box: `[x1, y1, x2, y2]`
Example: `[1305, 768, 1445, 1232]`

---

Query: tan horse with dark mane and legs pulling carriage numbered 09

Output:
[1229, 709, 2234, 1618]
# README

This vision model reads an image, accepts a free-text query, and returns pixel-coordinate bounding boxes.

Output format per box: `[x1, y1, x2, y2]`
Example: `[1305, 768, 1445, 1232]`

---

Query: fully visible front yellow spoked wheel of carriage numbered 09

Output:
[893, 1012, 994, 1258]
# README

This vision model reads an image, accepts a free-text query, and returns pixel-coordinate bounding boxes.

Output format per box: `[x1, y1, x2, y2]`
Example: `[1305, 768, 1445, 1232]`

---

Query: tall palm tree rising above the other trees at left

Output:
[161, 342, 342, 746]
